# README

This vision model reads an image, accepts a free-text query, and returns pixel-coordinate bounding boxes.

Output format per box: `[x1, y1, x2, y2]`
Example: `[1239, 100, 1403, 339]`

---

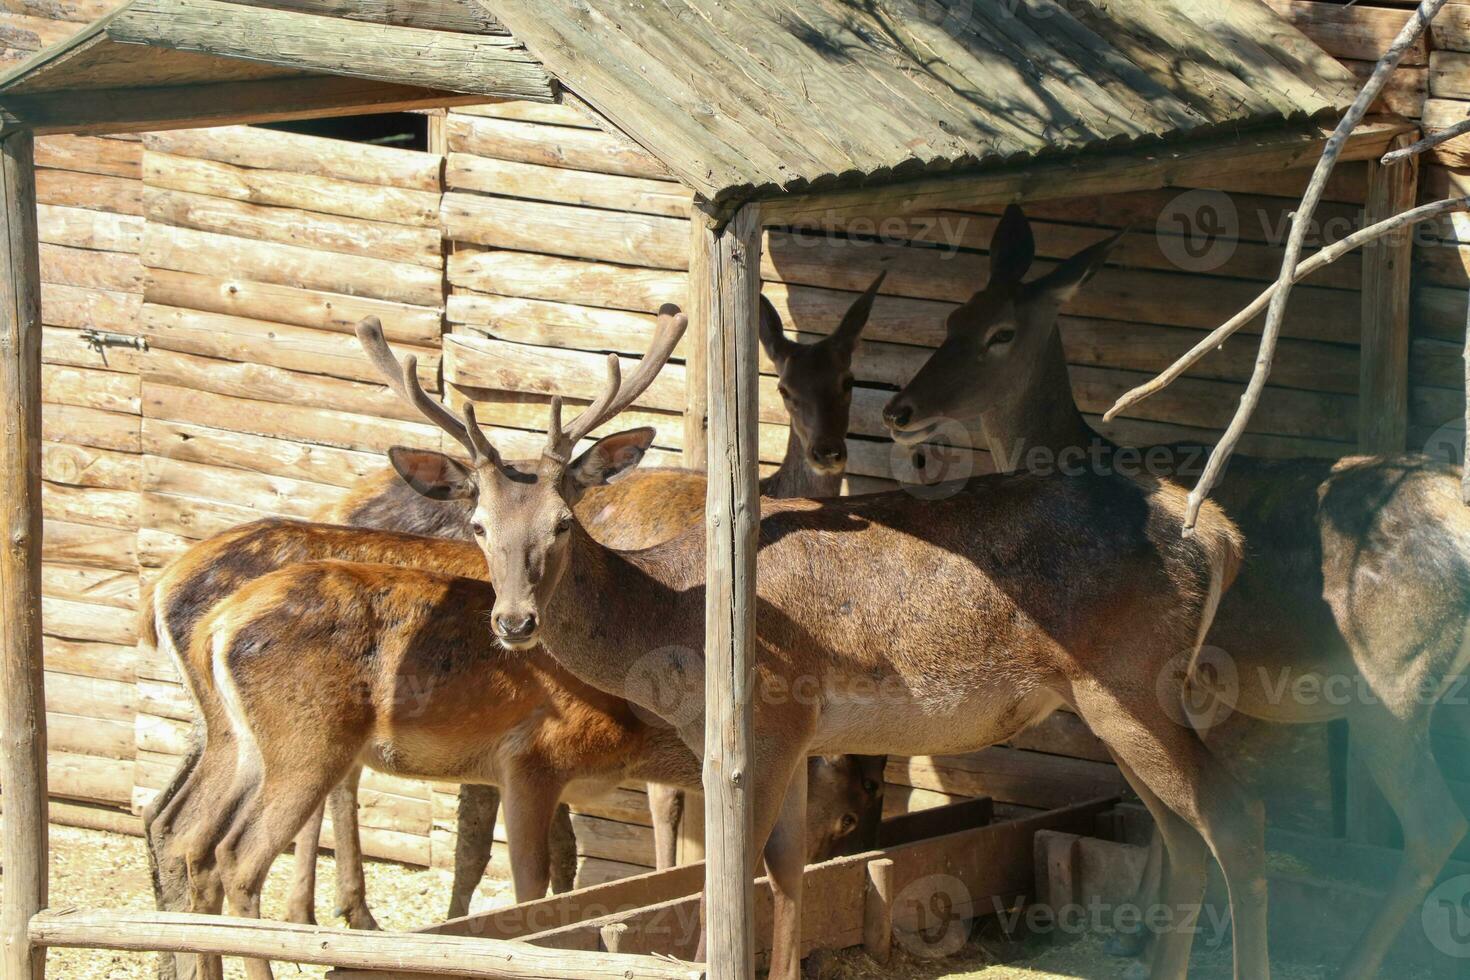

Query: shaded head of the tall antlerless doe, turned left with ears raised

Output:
[883, 213, 1123, 445]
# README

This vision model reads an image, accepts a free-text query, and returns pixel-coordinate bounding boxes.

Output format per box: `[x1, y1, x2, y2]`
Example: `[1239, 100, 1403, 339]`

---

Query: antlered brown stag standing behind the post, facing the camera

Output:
[370, 302, 1270, 980]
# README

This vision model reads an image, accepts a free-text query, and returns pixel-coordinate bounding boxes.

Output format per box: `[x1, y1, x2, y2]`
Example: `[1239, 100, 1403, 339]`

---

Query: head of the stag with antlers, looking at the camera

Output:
[357, 303, 689, 649]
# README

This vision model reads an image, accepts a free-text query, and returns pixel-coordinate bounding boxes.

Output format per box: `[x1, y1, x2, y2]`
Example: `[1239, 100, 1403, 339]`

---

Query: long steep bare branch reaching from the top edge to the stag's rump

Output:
[1183, 0, 1445, 535]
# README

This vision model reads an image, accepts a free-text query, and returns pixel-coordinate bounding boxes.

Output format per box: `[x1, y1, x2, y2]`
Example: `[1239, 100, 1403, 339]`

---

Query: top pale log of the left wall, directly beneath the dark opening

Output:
[143, 126, 441, 194]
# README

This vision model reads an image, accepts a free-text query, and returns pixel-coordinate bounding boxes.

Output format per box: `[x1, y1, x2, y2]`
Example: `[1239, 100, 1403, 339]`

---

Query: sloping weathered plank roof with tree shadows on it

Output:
[482, 0, 1357, 201]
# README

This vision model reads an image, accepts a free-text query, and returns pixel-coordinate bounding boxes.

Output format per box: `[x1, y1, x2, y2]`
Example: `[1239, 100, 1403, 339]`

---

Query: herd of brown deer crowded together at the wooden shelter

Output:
[144, 207, 1470, 980]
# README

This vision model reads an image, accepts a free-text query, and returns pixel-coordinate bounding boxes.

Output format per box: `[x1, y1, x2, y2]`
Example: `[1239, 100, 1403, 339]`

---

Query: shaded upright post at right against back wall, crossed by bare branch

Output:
[1358, 134, 1419, 453]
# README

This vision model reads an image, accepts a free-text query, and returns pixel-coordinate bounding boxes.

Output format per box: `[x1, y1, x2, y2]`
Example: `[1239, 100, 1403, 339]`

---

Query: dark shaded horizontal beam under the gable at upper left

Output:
[0, 75, 493, 134]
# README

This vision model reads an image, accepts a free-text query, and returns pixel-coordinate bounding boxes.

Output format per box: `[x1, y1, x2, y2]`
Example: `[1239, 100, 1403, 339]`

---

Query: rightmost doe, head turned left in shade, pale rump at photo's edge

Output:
[883, 206, 1470, 980]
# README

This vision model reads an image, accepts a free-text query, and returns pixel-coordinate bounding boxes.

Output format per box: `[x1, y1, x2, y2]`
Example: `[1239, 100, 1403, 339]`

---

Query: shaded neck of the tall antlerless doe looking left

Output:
[980, 329, 1100, 472]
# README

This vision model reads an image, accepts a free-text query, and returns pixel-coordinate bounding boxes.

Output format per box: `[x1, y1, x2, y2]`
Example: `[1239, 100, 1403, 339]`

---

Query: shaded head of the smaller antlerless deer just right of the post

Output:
[760, 272, 888, 476]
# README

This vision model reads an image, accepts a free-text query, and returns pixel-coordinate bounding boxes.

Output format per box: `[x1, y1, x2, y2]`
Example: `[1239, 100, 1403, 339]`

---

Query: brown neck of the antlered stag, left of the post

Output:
[541, 523, 704, 701]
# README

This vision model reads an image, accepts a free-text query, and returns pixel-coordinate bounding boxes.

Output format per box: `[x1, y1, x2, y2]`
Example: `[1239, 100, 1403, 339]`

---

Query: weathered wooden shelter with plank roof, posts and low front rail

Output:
[0, 0, 1411, 977]
